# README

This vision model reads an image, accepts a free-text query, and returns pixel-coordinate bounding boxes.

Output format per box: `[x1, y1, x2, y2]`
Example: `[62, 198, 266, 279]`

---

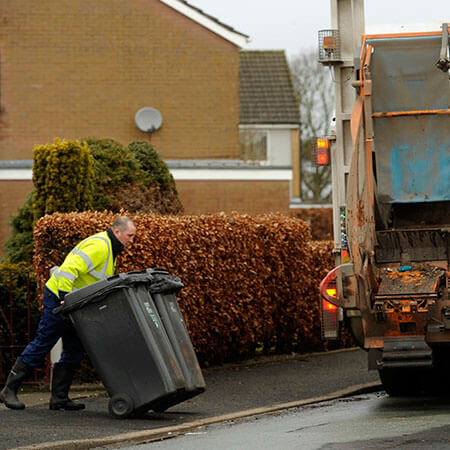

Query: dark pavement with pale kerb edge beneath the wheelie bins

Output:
[0, 349, 379, 449]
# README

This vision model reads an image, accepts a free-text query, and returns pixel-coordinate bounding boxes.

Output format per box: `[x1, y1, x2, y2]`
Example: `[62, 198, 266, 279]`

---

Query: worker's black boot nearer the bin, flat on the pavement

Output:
[50, 363, 85, 411]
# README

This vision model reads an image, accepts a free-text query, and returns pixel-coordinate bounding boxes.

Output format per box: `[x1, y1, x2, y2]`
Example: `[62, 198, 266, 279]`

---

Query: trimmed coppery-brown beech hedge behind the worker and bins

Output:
[34, 212, 345, 366]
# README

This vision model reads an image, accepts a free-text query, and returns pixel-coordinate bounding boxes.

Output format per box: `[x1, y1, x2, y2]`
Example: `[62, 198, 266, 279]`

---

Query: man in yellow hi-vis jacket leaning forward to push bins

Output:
[0, 216, 136, 410]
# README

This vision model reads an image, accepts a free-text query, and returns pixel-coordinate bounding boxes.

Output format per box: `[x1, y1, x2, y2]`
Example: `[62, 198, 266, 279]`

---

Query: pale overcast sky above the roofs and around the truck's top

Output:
[188, 0, 450, 57]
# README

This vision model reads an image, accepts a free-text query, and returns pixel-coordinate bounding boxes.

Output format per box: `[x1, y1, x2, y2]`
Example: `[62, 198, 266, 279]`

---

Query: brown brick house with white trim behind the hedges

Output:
[0, 0, 299, 253]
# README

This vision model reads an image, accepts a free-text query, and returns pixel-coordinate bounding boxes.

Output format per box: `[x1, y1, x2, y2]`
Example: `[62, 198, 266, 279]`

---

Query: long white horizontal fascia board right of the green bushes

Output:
[170, 169, 292, 181]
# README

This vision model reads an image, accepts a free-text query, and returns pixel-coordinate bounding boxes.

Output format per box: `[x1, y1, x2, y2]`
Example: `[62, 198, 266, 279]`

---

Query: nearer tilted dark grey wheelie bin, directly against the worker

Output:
[57, 271, 186, 418]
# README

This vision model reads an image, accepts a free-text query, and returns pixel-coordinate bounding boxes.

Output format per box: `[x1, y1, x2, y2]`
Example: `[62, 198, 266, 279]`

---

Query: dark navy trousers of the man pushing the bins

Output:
[19, 288, 84, 367]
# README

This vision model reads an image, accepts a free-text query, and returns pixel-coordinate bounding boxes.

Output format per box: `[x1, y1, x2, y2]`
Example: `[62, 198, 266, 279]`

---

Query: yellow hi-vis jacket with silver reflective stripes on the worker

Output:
[46, 231, 116, 296]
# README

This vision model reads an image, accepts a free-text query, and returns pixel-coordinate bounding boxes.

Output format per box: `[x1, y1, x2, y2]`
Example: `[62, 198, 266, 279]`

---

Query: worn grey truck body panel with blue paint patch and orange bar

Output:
[366, 36, 450, 203]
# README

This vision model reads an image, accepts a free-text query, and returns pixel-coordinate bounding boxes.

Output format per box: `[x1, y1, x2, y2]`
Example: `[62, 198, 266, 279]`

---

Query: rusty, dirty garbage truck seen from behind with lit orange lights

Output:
[317, 0, 450, 395]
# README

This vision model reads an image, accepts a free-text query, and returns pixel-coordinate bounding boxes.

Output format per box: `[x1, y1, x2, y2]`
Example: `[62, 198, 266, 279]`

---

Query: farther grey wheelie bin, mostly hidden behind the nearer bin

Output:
[139, 269, 205, 411]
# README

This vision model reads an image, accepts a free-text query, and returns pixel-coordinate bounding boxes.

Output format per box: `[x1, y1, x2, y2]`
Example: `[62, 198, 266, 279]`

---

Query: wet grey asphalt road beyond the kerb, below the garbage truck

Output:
[136, 392, 450, 450]
